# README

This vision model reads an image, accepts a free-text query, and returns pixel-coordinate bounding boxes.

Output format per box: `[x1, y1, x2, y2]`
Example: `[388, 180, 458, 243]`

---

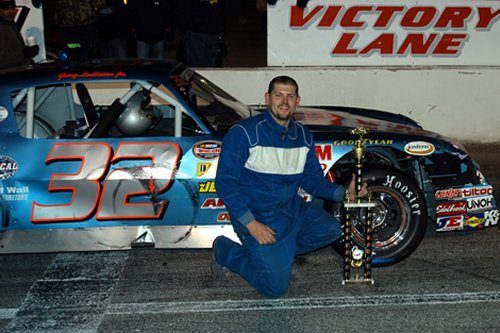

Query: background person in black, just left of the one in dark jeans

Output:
[128, 0, 173, 59]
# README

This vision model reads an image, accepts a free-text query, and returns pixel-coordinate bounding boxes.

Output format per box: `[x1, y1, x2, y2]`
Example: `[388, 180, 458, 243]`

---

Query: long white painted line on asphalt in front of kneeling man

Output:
[106, 291, 500, 315]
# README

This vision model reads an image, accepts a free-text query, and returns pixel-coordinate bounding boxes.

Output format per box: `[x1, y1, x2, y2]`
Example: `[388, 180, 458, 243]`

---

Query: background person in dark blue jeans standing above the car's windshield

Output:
[176, 0, 227, 67]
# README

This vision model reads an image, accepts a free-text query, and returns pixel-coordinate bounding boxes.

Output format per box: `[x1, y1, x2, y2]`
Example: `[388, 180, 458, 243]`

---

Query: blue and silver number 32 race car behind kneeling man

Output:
[0, 60, 499, 266]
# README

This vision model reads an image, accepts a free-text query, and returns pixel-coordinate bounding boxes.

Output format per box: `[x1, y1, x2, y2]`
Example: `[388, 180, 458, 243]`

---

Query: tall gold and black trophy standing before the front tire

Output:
[342, 127, 375, 285]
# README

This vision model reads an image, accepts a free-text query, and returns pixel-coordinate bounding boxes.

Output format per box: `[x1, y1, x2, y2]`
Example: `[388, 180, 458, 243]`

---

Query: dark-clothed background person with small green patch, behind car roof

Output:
[54, 0, 106, 61]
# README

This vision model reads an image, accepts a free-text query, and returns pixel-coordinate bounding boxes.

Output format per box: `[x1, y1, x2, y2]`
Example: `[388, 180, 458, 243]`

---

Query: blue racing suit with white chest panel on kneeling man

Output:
[214, 110, 345, 297]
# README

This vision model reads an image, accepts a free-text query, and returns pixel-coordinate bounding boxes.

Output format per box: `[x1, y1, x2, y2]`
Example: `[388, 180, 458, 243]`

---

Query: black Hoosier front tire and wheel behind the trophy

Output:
[327, 169, 427, 266]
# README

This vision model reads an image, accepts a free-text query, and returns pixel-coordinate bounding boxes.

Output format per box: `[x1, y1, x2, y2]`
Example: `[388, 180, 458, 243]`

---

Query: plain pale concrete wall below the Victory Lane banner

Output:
[198, 67, 500, 143]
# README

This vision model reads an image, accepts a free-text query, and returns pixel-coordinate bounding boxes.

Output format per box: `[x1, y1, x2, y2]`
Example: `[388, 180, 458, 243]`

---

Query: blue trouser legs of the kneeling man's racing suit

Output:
[214, 202, 341, 298]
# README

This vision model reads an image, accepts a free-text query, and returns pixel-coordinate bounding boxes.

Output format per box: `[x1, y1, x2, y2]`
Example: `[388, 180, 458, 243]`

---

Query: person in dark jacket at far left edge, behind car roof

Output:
[0, 0, 39, 68]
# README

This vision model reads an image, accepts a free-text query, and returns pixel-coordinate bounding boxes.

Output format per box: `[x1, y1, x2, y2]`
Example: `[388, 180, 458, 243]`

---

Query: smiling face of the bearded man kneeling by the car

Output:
[266, 83, 300, 127]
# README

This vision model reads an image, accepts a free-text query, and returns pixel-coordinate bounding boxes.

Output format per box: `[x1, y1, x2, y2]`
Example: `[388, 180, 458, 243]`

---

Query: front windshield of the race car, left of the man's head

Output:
[171, 67, 251, 131]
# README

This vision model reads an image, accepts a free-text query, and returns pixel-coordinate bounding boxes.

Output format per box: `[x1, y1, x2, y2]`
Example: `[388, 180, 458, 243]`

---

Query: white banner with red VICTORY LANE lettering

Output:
[268, 0, 500, 66]
